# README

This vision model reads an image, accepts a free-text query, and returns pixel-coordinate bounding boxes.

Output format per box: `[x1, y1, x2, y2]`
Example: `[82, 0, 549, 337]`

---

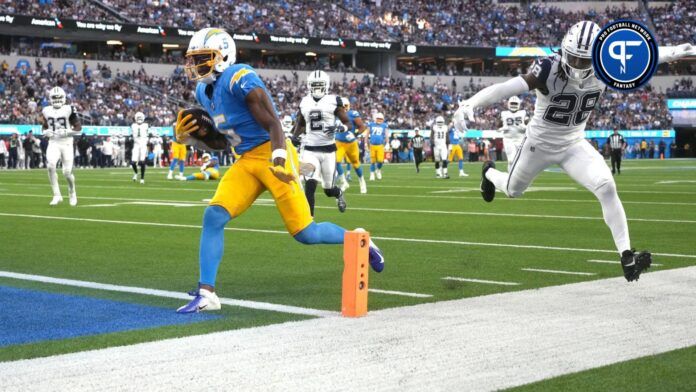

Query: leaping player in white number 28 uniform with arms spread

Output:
[455, 21, 696, 281]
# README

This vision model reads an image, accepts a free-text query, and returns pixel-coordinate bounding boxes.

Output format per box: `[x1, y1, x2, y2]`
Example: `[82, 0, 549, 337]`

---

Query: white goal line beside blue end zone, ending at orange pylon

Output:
[0, 271, 338, 317]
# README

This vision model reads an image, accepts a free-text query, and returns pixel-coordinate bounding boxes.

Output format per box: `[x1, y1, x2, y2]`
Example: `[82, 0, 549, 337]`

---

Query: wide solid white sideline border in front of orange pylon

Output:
[0, 267, 696, 391]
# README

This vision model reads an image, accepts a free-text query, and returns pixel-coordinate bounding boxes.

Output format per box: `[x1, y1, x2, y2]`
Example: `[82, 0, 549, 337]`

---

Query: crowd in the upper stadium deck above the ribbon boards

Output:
[0, 0, 696, 46]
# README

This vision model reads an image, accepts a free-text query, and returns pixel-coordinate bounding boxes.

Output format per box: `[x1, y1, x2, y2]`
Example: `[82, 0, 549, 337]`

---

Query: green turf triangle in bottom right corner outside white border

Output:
[509, 346, 696, 392]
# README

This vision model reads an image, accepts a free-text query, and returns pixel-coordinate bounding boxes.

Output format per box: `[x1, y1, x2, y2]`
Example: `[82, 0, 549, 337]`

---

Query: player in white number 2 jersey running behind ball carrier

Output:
[293, 71, 350, 216]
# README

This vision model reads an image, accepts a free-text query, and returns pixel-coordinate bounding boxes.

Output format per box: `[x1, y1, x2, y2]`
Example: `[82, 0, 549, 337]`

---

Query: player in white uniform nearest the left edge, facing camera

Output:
[42, 87, 82, 207]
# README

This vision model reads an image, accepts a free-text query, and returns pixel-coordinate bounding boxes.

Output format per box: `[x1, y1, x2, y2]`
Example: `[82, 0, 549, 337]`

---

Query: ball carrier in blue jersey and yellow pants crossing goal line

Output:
[175, 28, 384, 313]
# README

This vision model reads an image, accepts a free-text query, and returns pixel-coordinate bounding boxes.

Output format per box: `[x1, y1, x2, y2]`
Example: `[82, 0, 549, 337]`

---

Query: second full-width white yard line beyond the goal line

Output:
[0, 193, 696, 224]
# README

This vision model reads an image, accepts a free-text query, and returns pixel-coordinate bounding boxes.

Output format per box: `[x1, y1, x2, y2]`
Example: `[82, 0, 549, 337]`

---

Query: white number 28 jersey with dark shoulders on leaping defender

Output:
[527, 55, 606, 146]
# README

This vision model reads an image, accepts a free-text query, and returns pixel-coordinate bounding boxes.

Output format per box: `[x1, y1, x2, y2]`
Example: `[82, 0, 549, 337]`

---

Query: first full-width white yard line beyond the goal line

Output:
[0, 212, 696, 259]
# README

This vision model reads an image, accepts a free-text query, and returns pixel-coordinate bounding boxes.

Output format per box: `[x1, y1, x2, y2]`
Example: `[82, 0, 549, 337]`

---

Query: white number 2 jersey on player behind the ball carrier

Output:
[300, 94, 343, 146]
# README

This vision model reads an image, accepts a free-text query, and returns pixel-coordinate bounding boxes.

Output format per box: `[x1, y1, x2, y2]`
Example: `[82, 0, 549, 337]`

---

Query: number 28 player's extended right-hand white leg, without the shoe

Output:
[559, 140, 631, 254]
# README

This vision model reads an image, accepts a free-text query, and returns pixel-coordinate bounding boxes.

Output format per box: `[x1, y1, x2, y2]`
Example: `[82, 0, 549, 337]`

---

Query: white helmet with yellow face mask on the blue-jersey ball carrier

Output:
[184, 27, 237, 84]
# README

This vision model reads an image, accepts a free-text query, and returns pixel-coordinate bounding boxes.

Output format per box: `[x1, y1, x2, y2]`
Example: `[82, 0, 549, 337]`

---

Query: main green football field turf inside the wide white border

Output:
[0, 160, 696, 361]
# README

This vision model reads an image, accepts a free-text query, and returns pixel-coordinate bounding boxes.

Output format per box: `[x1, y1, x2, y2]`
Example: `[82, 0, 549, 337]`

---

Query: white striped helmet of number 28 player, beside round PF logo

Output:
[561, 21, 600, 82]
